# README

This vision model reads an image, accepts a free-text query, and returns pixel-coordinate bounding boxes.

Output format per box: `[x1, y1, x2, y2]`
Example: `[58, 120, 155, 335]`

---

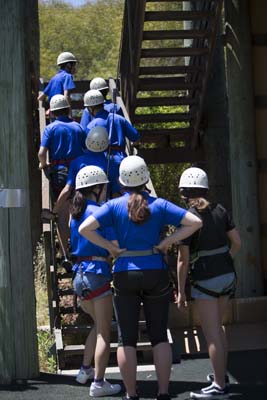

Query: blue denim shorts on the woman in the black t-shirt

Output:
[191, 272, 235, 300]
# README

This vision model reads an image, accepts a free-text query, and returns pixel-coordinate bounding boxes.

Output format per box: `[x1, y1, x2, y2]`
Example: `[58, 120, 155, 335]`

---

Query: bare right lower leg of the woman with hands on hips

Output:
[153, 342, 172, 394]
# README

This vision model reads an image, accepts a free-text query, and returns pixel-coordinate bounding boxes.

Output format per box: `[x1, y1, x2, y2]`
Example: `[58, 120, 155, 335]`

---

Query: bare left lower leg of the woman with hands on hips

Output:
[117, 346, 137, 396]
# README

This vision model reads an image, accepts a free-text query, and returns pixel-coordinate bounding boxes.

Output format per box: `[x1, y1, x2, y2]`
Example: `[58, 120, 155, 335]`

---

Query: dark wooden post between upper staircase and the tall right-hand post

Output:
[204, 19, 232, 212]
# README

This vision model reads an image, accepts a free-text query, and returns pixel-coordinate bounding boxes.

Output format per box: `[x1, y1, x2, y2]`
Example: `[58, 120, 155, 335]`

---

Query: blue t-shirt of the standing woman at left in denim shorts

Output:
[70, 200, 116, 277]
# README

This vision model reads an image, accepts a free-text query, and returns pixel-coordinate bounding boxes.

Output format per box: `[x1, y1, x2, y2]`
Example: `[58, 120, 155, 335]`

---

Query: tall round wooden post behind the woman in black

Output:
[225, 0, 262, 297]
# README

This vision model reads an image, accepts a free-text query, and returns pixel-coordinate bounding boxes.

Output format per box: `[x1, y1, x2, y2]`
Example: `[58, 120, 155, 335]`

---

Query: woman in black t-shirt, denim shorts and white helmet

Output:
[177, 168, 241, 399]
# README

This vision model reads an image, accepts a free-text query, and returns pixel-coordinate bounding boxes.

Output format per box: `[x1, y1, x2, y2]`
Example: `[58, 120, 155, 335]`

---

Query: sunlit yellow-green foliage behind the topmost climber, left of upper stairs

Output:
[39, 0, 124, 81]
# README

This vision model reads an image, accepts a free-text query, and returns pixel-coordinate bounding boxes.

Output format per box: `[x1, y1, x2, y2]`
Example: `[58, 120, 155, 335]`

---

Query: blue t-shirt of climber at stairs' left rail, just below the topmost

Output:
[41, 116, 86, 167]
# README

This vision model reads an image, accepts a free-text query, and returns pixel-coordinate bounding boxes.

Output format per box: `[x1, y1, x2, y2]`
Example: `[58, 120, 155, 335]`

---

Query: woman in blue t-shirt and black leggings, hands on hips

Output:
[79, 156, 201, 400]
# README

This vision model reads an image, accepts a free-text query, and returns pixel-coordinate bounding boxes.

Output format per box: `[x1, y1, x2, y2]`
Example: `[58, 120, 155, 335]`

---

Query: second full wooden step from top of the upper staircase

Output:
[143, 29, 210, 40]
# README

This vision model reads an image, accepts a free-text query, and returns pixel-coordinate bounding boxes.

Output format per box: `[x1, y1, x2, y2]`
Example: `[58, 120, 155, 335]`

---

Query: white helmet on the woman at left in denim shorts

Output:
[75, 165, 108, 190]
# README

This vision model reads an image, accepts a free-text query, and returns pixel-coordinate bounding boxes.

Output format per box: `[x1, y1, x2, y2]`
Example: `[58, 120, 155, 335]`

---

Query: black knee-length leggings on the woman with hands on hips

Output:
[113, 269, 171, 347]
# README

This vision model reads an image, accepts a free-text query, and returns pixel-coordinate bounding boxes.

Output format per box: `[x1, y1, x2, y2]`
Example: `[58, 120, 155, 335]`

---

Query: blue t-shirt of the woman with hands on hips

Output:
[93, 192, 187, 272]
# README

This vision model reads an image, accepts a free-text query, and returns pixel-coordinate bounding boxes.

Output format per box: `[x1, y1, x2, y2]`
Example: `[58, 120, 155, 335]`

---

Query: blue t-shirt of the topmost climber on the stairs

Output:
[44, 69, 76, 102]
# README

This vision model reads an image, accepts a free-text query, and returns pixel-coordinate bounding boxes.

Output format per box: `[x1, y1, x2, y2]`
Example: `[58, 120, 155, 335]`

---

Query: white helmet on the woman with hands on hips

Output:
[119, 156, 150, 187]
